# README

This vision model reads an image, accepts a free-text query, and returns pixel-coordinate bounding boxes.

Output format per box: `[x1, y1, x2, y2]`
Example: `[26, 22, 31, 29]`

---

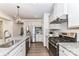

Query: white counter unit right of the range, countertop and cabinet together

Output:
[59, 42, 79, 56]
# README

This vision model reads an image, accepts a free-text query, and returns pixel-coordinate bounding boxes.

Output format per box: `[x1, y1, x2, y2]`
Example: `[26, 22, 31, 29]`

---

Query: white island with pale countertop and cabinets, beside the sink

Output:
[0, 36, 29, 56]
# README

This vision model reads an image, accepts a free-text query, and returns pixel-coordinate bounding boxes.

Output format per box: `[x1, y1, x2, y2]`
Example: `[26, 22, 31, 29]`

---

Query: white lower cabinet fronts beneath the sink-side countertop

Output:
[7, 41, 26, 56]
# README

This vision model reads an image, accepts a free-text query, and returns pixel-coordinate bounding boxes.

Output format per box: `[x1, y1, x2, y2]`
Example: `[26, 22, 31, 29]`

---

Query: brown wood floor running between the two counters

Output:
[27, 42, 49, 56]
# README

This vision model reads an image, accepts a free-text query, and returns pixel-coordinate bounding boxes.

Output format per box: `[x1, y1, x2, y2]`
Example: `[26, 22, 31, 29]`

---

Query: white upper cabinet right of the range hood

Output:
[68, 3, 79, 28]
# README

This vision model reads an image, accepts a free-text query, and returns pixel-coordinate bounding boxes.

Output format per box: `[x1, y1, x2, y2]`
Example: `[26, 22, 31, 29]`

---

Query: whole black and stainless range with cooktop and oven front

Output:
[49, 35, 77, 56]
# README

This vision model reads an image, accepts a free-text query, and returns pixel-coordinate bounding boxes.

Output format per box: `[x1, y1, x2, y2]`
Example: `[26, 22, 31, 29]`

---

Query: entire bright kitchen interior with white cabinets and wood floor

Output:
[0, 3, 79, 56]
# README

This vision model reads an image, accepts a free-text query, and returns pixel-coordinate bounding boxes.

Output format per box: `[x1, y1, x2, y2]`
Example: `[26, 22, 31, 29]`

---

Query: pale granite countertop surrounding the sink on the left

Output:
[0, 36, 29, 56]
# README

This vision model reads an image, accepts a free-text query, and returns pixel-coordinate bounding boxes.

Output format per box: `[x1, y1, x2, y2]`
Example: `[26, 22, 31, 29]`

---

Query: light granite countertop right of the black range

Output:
[59, 42, 79, 56]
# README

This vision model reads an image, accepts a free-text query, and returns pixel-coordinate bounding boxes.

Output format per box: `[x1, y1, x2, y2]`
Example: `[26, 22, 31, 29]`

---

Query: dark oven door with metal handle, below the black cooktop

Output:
[49, 42, 59, 56]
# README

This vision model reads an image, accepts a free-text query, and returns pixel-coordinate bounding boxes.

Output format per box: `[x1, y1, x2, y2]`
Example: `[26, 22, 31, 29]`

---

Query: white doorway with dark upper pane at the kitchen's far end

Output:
[33, 27, 43, 42]
